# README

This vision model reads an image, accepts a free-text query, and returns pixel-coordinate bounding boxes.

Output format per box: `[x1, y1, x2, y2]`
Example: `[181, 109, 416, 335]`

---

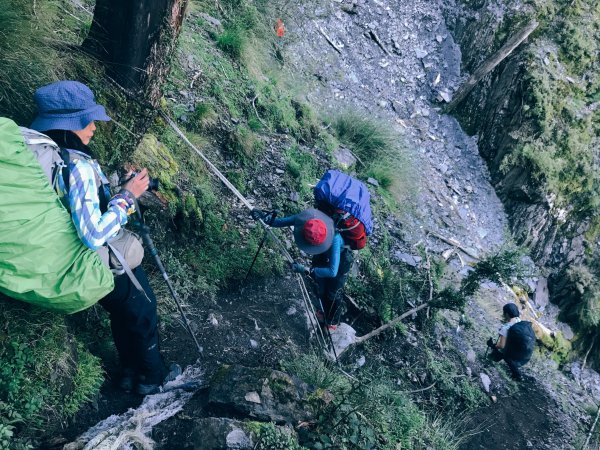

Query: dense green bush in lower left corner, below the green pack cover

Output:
[0, 298, 103, 440]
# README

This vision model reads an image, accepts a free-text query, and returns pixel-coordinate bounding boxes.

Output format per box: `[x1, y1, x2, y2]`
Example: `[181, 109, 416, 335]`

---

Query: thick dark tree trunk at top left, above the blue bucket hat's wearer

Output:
[83, 0, 187, 105]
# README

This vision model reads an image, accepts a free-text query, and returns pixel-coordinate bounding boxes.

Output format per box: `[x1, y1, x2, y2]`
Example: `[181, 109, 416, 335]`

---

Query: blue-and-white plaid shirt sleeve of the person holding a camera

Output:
[69, 159, 131, 250]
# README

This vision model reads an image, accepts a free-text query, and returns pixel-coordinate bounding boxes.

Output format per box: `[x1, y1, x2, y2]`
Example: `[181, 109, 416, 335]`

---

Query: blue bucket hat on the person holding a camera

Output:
[31, 81, 111, 131]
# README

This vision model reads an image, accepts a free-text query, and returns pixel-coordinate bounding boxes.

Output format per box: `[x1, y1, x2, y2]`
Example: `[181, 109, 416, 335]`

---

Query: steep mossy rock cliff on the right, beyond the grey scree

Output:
[446, 0, 600, 358]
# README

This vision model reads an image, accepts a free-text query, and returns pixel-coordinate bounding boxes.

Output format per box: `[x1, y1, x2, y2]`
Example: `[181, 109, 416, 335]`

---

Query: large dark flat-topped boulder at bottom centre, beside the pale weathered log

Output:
[208, 366, 313, 424]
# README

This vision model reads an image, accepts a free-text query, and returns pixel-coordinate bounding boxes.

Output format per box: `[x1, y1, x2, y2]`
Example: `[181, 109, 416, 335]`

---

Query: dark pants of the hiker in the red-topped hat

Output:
[313, 247, 354, 325]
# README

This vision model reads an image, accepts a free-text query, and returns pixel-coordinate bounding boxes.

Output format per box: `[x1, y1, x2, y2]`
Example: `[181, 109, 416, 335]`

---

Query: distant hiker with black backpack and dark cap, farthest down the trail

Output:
[487, 303, 535, 381]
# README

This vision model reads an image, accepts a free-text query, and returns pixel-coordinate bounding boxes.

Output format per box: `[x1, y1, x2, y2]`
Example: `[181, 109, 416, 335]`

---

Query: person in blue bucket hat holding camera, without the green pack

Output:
[31, 81, 181, 395]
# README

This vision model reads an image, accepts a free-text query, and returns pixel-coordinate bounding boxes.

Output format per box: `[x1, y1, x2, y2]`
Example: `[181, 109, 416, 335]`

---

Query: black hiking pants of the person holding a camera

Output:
[99, 267, 166, 384]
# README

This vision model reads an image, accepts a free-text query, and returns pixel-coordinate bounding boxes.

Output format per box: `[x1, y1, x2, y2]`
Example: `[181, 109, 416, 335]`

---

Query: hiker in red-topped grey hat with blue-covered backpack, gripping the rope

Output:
[252, 170, 373, 330]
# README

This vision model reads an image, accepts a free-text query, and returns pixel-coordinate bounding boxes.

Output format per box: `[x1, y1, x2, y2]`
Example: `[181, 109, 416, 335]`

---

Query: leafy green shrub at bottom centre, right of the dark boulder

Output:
[283, 355, 455, 450]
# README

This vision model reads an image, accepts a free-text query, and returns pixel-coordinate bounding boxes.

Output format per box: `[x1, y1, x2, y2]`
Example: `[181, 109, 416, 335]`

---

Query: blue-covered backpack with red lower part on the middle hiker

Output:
[314, 170, 373, 250]
